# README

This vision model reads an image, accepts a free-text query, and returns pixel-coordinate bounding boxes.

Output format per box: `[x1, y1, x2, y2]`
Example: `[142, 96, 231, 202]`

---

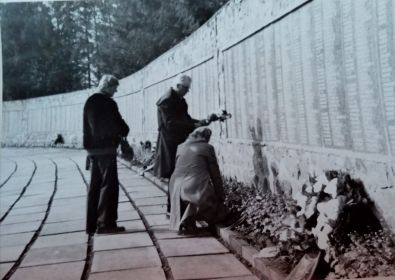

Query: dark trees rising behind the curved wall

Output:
[0, 0, 228, 100]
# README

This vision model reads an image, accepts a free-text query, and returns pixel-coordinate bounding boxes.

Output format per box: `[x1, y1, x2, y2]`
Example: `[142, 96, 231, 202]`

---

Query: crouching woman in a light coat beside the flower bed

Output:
[169, 127, 229, 234]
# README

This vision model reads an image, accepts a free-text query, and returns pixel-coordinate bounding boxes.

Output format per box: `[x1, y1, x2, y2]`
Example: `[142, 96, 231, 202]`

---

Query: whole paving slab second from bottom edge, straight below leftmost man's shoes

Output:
[91, 247, 161, 272]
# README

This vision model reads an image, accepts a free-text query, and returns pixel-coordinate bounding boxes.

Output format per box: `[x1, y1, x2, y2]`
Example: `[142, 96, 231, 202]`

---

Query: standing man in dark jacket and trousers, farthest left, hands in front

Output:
[83, 75, 129, 234]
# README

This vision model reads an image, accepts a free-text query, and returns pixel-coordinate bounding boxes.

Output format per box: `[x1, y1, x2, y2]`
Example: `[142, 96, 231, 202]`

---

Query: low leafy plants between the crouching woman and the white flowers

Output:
[224, 179, 316, 273]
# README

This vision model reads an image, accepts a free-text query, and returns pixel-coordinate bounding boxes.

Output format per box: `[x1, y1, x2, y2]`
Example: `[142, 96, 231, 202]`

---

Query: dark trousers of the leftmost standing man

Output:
[86, 155, 119, 233]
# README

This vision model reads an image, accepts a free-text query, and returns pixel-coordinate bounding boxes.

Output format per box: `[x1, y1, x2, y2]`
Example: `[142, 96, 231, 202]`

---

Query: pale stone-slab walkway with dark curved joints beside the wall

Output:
[0, 148, 257, 280]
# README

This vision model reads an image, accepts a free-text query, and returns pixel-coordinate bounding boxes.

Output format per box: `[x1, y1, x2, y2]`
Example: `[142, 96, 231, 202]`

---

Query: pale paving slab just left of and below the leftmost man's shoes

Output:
[32, 232, 88, 249]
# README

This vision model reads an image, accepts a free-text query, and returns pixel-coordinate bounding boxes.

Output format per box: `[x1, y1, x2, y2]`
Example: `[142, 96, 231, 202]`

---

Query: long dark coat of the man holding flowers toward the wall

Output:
[154, 89, 198, 178]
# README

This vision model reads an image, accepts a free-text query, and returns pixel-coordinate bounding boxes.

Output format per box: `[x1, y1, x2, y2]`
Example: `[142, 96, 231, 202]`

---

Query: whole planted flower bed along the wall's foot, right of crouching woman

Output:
[224, 176, 395, 279]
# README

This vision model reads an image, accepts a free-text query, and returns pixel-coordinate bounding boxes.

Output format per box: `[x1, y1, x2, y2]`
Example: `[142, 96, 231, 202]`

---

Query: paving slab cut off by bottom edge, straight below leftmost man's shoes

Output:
[89, 267, 166, 280]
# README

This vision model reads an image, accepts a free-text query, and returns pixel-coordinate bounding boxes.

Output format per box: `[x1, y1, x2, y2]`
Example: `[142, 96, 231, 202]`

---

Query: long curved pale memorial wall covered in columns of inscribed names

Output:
[2, 0, 395, 229]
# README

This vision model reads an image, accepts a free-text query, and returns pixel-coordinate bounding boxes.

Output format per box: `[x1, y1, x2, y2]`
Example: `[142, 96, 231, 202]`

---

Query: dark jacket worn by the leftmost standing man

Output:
[83, 93, 129, 153]
